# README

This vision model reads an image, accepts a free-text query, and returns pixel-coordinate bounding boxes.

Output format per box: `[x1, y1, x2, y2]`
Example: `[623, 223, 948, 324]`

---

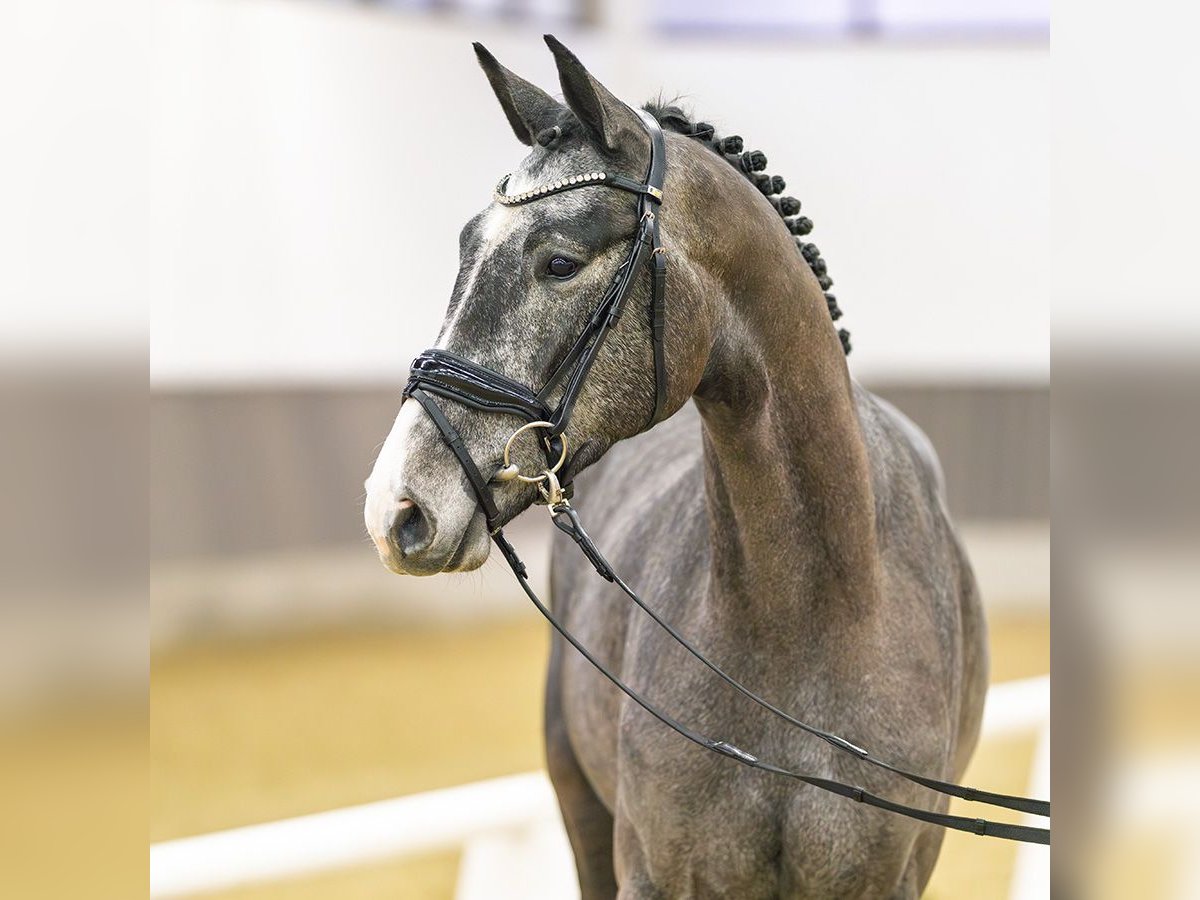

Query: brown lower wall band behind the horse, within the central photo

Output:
[150, 385, 1050, 559]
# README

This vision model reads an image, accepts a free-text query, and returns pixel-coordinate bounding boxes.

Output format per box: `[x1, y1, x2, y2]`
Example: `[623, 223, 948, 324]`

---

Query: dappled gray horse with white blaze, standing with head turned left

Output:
[365, 38, 988, 900]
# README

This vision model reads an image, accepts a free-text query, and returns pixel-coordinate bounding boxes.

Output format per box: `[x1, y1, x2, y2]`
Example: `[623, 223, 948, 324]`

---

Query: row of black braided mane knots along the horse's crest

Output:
[642, 100, 850, 354]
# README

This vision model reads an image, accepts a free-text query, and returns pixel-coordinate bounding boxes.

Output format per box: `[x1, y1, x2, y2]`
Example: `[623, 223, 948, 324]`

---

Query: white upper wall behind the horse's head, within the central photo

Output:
[150, 0, 1050, 385]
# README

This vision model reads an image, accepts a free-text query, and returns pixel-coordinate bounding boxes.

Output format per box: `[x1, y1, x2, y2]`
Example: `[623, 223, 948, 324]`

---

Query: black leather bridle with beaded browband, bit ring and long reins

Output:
[404, 110, 1050, 844]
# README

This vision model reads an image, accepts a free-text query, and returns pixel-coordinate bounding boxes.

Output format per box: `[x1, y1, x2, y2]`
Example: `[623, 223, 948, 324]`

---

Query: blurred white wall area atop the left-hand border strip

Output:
[0, 0, 149, 355]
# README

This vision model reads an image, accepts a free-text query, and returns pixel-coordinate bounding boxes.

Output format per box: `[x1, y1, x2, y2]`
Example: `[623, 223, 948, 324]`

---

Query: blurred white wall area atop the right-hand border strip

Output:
[1054, 0, 1200, 345]
